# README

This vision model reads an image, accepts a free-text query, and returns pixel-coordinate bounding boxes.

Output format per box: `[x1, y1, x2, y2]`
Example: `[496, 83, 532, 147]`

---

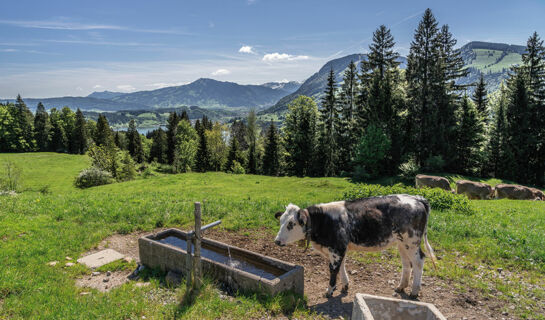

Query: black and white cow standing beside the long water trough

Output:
[275, 194, 435, 298]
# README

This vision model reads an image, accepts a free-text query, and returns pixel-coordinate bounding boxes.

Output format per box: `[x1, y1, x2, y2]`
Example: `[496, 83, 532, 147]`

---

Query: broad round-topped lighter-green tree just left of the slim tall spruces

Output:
[283, 96, 322, 176]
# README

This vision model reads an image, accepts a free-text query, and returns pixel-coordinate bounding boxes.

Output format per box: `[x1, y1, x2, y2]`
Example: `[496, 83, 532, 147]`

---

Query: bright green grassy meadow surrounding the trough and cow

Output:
[0, 153, 545, 319]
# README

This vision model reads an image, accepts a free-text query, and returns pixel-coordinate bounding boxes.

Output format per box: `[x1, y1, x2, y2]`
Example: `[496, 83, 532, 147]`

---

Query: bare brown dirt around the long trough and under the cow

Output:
[78, 229, 516, 320]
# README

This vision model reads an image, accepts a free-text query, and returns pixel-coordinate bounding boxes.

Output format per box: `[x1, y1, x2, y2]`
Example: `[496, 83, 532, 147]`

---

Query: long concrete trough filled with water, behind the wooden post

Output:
[138, 229, 304, 295]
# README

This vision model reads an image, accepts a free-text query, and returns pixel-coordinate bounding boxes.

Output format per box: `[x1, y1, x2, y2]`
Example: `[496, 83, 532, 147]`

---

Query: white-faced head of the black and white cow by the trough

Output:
[274, 203, 309, 246]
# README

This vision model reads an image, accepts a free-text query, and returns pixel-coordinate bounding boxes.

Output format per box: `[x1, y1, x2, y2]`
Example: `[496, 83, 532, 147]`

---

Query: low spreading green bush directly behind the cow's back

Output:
[343, 184, 473, 214]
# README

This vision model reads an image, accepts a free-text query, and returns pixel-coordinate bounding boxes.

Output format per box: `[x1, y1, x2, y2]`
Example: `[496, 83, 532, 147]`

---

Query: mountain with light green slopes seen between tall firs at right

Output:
[459, 41, 526, 91]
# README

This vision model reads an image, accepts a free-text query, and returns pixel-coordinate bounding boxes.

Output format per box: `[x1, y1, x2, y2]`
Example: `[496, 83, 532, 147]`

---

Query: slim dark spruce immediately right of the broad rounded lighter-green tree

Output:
[318, 69, 339, 177]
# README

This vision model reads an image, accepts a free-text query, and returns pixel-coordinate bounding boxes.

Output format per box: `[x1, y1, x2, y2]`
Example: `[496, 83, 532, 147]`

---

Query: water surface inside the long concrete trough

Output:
[158, 236, 286, 280]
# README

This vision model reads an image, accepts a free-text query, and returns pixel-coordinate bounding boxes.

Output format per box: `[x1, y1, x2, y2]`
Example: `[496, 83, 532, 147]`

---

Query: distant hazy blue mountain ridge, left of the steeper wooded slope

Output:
[111, 78, 296, 110]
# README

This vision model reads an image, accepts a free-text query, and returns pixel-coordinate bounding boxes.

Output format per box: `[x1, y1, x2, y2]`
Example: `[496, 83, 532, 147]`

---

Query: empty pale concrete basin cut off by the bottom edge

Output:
[352, 293, 446, 320]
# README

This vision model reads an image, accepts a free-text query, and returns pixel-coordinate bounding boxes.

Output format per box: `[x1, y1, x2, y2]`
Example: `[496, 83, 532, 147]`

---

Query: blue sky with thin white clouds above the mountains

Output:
[0, 0, 545, 98]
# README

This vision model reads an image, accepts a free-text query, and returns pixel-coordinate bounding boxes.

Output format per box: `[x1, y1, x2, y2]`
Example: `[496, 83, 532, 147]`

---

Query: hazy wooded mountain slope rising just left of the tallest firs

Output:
[260, 54, 407, 114]
